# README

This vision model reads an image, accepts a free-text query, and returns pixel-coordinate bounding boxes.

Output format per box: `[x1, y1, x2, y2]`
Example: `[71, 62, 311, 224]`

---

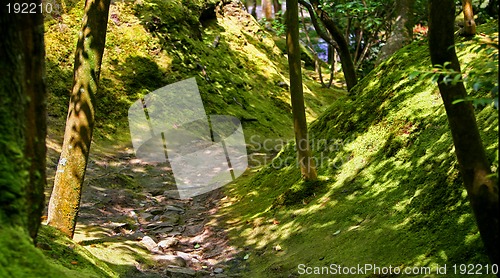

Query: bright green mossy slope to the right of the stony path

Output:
[214, 22, 498, 277]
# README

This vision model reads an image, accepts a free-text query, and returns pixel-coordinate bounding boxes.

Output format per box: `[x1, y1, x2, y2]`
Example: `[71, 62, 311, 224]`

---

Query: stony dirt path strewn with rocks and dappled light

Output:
[47, 133, 250, 277]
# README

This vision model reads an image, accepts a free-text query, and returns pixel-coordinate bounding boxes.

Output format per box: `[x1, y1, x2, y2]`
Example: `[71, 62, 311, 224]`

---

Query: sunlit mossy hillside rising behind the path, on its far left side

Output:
[46, 0, 333, 149]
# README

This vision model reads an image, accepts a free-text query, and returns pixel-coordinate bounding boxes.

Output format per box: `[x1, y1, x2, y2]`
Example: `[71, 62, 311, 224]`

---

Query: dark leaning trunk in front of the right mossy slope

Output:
[429, 0, 500, 264]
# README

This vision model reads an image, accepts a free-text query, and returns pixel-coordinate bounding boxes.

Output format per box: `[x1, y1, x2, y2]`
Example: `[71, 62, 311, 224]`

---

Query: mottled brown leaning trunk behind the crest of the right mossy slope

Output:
[376, 0, 415, 65]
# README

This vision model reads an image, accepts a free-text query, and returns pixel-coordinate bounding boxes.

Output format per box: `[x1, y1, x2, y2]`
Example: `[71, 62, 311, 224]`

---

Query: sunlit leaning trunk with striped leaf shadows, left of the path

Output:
[48, 0, 110, 238]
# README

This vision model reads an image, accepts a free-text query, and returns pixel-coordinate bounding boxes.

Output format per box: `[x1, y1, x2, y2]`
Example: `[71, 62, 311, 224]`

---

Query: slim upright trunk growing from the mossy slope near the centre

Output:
[286, 0, 317, 181]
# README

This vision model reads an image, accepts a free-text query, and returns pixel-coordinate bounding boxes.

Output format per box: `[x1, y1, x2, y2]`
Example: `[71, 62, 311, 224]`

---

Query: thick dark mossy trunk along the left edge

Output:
[0, 1, 46, 240]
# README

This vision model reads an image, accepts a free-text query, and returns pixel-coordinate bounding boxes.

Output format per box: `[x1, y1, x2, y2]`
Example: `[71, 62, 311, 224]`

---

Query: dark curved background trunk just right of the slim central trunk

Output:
[311, 0, 358, 91]
